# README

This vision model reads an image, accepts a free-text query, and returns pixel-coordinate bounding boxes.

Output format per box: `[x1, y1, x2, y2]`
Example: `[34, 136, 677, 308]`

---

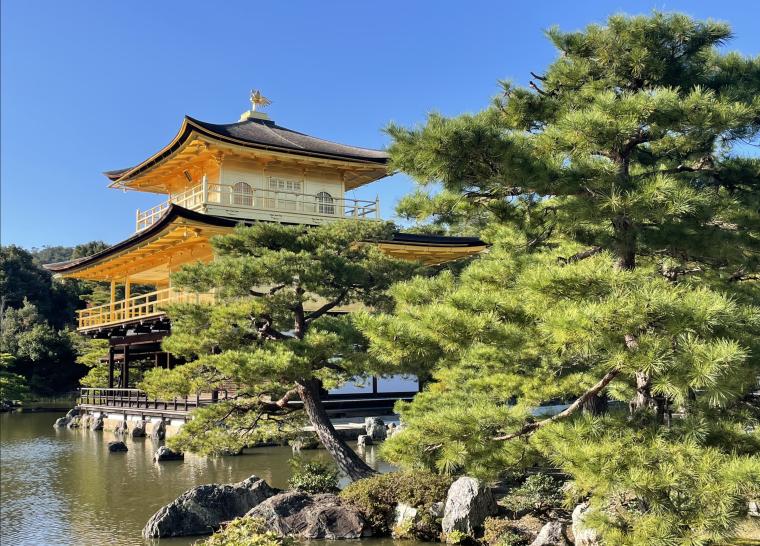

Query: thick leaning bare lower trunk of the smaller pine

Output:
[297, 379, 375, 480]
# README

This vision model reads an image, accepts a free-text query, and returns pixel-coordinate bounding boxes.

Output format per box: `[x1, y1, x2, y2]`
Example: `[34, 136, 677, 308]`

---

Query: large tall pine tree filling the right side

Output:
[357, 13, 760, 545]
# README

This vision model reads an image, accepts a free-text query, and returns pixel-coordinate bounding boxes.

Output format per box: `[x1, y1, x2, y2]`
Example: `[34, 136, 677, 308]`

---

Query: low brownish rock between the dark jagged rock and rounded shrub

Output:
[247, 491, 372, 540]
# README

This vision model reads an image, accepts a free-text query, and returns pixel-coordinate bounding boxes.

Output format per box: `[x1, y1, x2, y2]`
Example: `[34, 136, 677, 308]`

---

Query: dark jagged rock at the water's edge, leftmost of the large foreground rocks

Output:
[143, 476, 279, 538]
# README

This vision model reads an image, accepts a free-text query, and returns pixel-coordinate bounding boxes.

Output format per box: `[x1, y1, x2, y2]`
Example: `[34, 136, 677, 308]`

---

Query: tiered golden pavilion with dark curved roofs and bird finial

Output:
[46, 92, 485, 416]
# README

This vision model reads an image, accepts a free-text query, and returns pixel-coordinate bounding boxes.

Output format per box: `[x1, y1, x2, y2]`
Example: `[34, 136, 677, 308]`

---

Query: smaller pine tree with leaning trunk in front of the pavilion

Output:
[142, 221, 418, 479]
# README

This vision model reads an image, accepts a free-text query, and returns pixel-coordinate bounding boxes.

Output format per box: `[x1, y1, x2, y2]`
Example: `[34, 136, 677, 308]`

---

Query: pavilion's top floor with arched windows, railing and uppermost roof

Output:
[105, 112, 388, 231]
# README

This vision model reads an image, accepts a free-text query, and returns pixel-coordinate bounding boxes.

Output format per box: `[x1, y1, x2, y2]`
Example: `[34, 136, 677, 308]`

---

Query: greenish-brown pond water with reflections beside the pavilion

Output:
[0, 412, 413, 546]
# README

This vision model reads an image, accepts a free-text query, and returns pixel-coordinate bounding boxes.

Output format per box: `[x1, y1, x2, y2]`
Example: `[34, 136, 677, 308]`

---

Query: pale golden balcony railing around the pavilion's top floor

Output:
[136, 178, 380, 231]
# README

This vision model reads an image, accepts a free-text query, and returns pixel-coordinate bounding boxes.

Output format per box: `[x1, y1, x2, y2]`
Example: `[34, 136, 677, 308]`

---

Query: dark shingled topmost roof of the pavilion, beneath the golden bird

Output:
[103, 116, 388, 181]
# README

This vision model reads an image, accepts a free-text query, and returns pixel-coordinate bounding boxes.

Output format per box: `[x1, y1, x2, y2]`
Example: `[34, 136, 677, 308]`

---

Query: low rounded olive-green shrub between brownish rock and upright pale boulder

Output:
[340, 472, 451, 536]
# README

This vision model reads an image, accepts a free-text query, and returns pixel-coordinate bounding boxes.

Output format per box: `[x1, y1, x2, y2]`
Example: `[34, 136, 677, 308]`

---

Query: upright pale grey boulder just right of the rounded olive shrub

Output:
[442, 476, 496, 536]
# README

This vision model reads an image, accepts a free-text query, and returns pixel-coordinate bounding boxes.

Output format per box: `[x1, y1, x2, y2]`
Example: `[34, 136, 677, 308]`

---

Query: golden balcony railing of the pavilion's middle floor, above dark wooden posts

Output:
[77, 288, 214, 330]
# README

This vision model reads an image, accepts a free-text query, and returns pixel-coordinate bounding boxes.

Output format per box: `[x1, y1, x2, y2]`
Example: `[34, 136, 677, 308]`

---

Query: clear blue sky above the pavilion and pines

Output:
[0, 0, 760, 247]
